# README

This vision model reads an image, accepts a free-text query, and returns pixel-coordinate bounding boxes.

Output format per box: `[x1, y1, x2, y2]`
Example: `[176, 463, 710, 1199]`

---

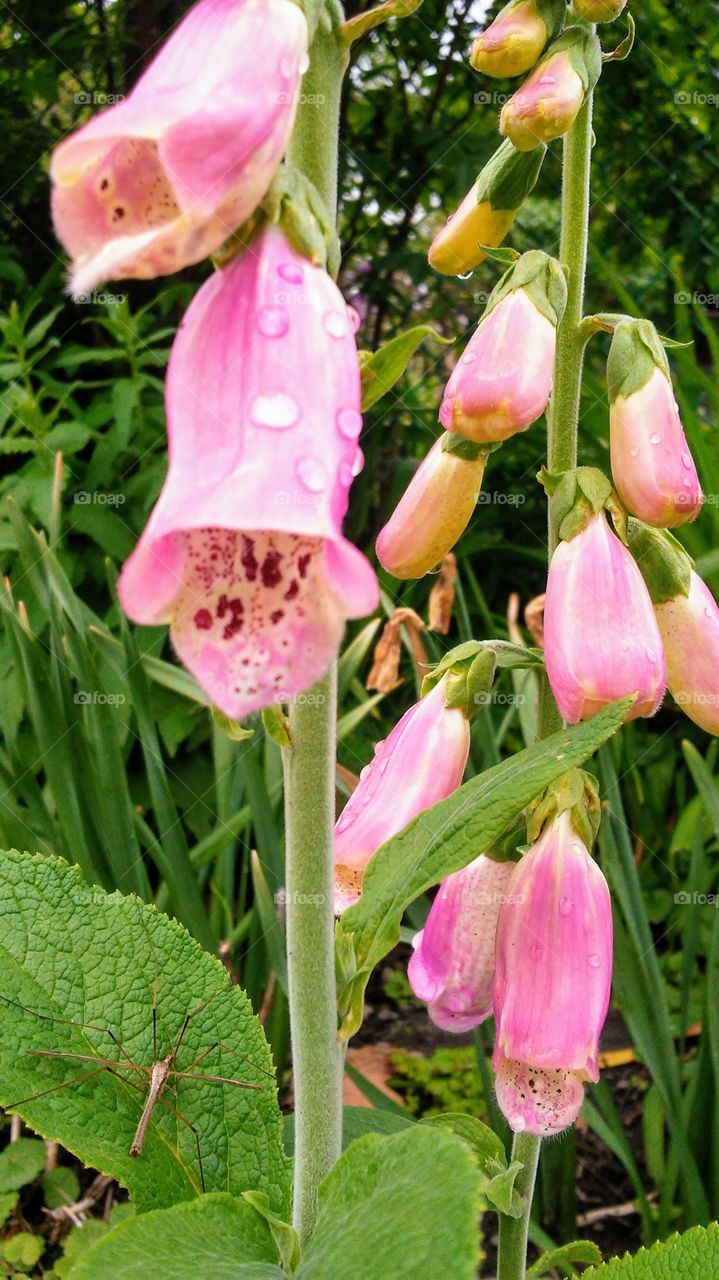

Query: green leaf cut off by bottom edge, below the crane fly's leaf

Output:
[65, 1193, 284, 1280]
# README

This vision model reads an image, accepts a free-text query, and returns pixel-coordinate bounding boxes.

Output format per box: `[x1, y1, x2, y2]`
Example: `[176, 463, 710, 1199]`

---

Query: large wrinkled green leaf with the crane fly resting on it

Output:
[0, 852, 289, 1212]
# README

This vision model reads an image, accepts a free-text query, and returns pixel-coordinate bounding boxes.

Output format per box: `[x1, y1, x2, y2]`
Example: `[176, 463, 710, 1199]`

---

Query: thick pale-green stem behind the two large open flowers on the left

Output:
[283, 0, 347, 1242]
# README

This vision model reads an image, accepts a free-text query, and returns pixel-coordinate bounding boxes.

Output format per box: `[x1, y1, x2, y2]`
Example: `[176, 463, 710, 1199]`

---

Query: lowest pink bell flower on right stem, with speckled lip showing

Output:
[494, 812, 612, 1134]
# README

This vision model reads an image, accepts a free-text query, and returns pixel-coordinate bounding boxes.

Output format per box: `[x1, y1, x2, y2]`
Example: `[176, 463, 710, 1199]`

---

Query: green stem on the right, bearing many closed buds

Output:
[498, 93, 592, 1280]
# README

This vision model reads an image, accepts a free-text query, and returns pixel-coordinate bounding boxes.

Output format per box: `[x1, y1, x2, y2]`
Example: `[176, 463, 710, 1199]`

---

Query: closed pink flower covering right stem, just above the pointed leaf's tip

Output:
[544, 512, 667, 724]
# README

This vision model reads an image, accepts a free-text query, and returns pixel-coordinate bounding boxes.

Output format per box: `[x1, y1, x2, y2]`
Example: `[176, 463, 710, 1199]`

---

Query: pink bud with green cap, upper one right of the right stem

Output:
[606, 320, 702, 529]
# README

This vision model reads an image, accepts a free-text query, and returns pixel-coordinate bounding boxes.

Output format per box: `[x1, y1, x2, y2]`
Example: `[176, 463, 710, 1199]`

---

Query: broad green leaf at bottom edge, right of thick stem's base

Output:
[297, 1125, 482, 1280]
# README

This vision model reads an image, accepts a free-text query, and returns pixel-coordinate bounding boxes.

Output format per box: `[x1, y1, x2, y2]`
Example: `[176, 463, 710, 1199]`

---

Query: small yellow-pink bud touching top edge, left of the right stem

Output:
[470, 0, 565, 78]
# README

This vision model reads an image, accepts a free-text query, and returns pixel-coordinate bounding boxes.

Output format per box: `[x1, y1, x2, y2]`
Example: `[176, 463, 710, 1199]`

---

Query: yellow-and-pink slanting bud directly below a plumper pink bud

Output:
[376, 435, 486, 579]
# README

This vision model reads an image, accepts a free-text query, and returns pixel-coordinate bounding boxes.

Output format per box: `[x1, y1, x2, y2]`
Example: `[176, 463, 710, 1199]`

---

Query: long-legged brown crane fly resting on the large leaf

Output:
[0, 974, 274, 1190]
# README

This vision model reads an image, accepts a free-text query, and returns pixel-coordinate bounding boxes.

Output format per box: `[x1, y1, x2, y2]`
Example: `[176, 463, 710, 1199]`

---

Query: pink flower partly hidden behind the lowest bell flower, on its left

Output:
[407, 854, 514, 1032]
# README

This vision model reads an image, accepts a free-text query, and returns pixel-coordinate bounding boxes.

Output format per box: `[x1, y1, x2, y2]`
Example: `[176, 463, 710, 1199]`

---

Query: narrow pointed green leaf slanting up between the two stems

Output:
[338, 699, 631, 1037]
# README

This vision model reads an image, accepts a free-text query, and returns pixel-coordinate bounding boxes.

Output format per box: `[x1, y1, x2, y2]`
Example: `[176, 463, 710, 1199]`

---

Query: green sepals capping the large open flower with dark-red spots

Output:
[212, 164, 340, 278]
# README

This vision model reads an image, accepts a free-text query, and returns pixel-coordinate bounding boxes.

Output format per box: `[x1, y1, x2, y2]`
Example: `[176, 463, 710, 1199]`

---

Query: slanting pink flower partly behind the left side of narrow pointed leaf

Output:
[334, 678, 470, 914]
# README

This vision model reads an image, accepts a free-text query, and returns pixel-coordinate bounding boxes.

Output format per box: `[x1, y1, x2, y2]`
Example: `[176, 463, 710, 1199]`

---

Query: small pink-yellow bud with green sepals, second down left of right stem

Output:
[499, 27, 601, 151]
